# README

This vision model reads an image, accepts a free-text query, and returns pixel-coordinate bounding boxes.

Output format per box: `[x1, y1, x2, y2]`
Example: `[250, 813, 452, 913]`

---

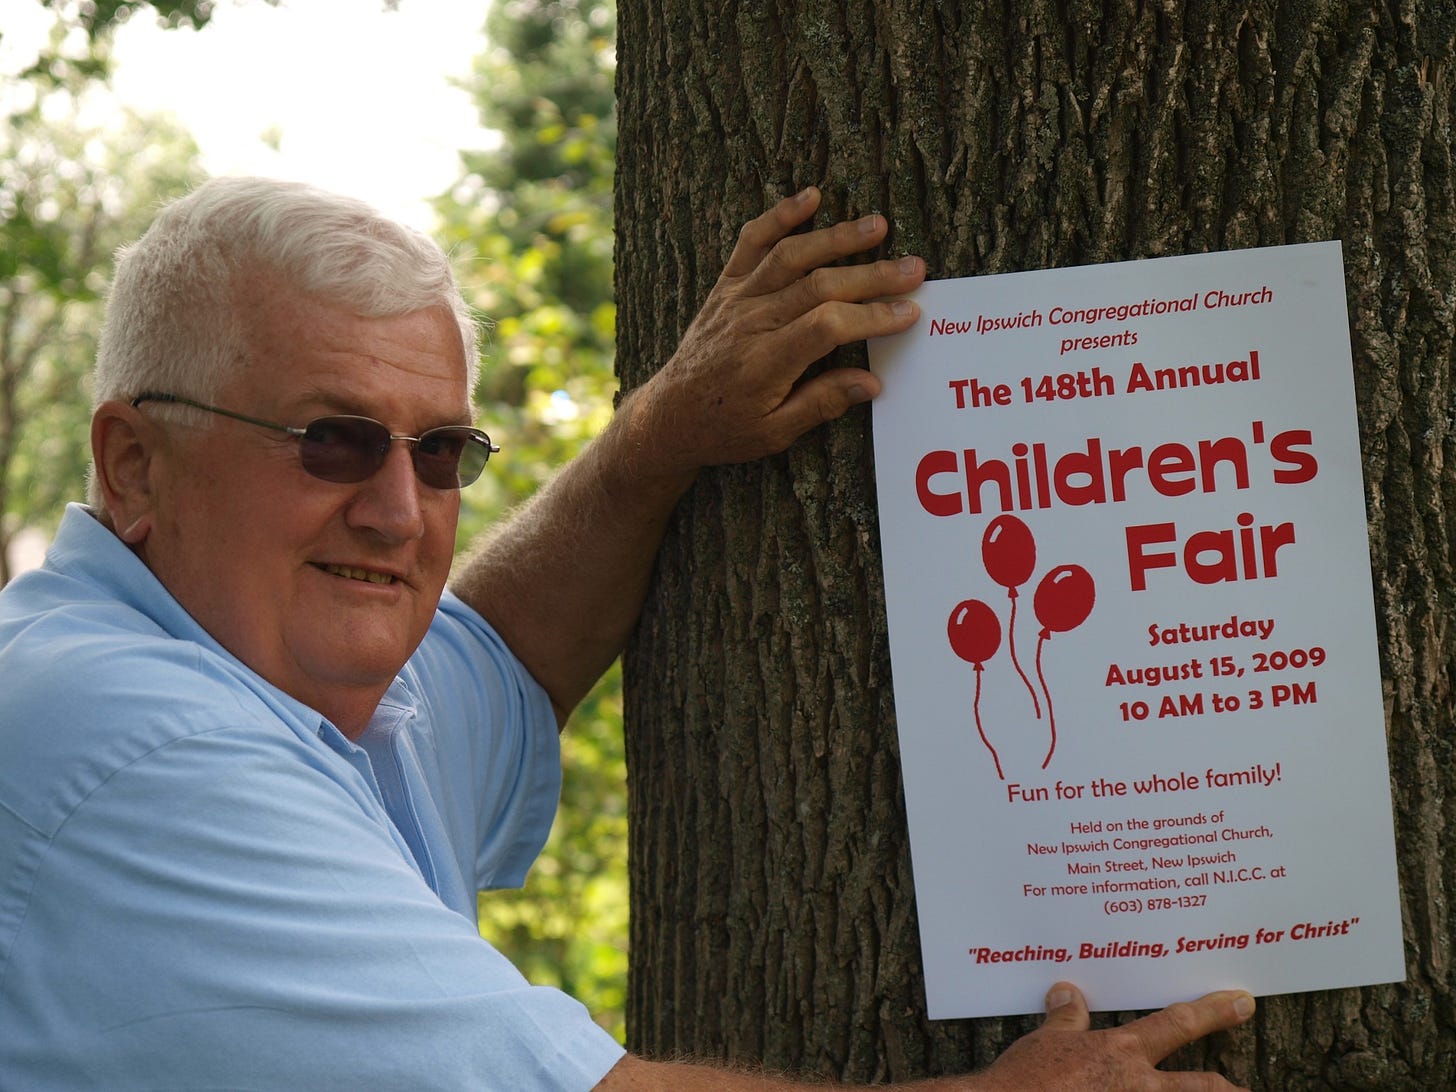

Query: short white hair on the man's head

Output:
[95, 178, 479, 405]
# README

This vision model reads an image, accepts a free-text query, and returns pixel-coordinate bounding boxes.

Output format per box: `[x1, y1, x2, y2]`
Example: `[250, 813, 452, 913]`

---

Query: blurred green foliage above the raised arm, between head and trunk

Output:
[435, 0, 616, 511]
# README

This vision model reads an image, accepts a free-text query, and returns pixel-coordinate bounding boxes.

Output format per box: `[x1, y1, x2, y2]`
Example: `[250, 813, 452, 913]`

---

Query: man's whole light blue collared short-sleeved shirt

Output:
[0, 505, 623, 1092]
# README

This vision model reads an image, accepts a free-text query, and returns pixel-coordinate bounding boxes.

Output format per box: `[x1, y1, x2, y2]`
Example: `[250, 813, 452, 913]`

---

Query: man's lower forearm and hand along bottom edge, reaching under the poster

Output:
[597, 983, 1254, 1092]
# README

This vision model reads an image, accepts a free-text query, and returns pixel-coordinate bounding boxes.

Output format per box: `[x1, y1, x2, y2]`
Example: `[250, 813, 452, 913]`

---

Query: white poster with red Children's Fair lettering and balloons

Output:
[871, 243, 1404, 1019]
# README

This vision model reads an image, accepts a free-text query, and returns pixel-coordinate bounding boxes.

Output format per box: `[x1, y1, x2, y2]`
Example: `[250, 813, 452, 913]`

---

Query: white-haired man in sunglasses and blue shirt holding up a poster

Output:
[0, 179, 1251, 1091]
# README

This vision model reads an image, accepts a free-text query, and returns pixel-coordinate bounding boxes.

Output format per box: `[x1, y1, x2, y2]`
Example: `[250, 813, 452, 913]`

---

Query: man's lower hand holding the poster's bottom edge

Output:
[974, 983, 1254, 1092]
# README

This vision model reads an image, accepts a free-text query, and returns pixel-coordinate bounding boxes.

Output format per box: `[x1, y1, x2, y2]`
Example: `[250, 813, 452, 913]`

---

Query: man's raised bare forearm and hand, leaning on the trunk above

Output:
[451, 188, 925, 721]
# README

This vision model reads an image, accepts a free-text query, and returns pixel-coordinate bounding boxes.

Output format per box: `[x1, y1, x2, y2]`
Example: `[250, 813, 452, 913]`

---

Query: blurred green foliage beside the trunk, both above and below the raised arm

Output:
[435, 0, 628, 1040]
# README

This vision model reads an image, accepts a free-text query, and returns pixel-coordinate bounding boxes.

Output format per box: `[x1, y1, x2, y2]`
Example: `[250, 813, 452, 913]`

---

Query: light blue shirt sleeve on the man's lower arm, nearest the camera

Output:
[0, 725, 623, 1092]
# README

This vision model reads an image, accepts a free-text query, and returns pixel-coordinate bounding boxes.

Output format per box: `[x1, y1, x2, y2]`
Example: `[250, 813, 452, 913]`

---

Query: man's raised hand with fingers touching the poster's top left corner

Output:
[623, 186, 925, 486]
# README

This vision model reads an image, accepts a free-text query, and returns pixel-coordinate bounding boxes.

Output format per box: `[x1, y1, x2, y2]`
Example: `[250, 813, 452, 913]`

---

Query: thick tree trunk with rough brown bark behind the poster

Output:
[616, 0, 1456, 1092]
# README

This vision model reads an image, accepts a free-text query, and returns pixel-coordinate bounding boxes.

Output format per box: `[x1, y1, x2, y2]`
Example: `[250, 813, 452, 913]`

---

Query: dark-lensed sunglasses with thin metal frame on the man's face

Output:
[131, 390, 501, 489]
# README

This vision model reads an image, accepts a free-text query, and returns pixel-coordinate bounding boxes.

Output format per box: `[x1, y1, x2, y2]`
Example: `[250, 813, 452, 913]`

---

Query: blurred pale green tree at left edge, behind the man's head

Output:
[0, 19, 199, 584]
